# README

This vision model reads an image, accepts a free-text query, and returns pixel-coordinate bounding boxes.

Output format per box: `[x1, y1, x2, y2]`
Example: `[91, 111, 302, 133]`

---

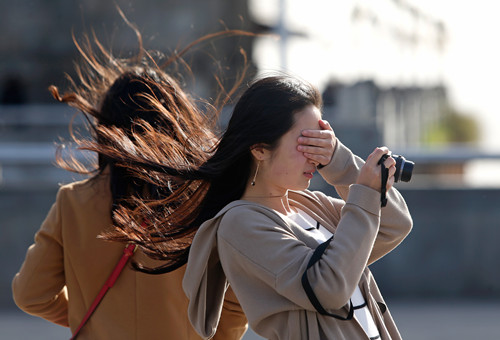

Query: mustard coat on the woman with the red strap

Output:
[12, 173, 247, 340]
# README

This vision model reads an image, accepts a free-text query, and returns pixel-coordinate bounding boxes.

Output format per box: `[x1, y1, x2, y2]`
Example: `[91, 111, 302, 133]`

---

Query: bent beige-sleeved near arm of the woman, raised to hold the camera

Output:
[217, 197, 380, 314]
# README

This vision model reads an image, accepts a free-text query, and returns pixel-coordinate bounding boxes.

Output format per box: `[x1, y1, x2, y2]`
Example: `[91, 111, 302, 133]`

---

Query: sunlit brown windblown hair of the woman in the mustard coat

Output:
[49, 11, 250, 271]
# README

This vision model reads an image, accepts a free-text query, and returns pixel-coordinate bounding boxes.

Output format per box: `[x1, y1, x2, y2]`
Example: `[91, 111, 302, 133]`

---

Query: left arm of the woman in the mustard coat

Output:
[12, 190, 68, 327]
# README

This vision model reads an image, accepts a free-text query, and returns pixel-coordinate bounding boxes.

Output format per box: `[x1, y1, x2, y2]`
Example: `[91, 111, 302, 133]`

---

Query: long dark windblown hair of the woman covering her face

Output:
[103, 75, 322, 273]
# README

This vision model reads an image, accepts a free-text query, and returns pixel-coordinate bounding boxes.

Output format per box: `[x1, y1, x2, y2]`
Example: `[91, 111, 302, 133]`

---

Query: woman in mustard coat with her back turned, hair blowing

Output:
[12, 25, 250, 339]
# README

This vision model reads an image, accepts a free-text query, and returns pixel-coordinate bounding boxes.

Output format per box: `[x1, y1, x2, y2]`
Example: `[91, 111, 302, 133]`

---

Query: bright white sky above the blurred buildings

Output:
[251, 0, 500, 153]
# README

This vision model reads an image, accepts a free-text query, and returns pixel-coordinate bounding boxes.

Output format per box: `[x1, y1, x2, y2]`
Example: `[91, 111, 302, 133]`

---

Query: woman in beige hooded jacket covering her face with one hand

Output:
[102, 76, 412, 339]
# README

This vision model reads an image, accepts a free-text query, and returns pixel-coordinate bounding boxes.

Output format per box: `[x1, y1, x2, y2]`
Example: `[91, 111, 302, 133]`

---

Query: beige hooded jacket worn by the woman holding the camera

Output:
[183, 143, 412, 340]
